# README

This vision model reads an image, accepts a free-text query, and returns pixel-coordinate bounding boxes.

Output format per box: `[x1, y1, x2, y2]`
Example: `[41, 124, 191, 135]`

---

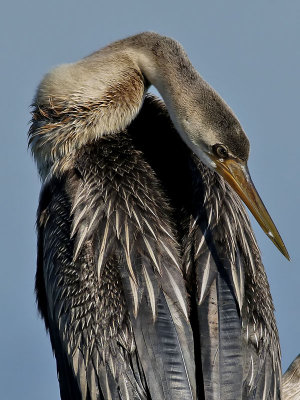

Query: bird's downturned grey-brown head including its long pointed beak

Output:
[177, 83, 290, 259]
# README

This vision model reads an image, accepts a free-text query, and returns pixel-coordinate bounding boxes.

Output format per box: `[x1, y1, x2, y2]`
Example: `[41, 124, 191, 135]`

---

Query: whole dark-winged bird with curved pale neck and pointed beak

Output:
[29, 32, 289, 400]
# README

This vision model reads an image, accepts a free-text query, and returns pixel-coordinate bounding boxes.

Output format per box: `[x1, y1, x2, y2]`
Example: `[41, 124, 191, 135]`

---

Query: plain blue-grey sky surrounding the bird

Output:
[0, 0, 300, 400]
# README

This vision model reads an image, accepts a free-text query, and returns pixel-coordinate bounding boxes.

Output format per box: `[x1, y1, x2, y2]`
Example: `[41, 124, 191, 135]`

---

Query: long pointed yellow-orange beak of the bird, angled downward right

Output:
[210, 155, 290, 260]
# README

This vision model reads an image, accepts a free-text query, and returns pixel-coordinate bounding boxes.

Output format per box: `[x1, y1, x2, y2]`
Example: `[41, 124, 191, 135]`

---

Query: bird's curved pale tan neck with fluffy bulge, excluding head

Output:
[29, 33, 204, 178]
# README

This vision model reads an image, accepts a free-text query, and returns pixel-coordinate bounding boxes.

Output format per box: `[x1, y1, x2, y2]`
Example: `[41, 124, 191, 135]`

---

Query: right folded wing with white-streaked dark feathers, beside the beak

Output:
[184, 161, 281, 400]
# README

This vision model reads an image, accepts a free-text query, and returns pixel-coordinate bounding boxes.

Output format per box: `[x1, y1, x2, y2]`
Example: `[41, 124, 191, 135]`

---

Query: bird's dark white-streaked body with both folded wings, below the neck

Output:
[36, 97, 280, 400]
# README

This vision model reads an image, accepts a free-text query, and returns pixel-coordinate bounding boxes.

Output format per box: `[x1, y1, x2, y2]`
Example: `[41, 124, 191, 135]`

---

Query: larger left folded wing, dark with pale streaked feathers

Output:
[38, 117, 196, 400]
